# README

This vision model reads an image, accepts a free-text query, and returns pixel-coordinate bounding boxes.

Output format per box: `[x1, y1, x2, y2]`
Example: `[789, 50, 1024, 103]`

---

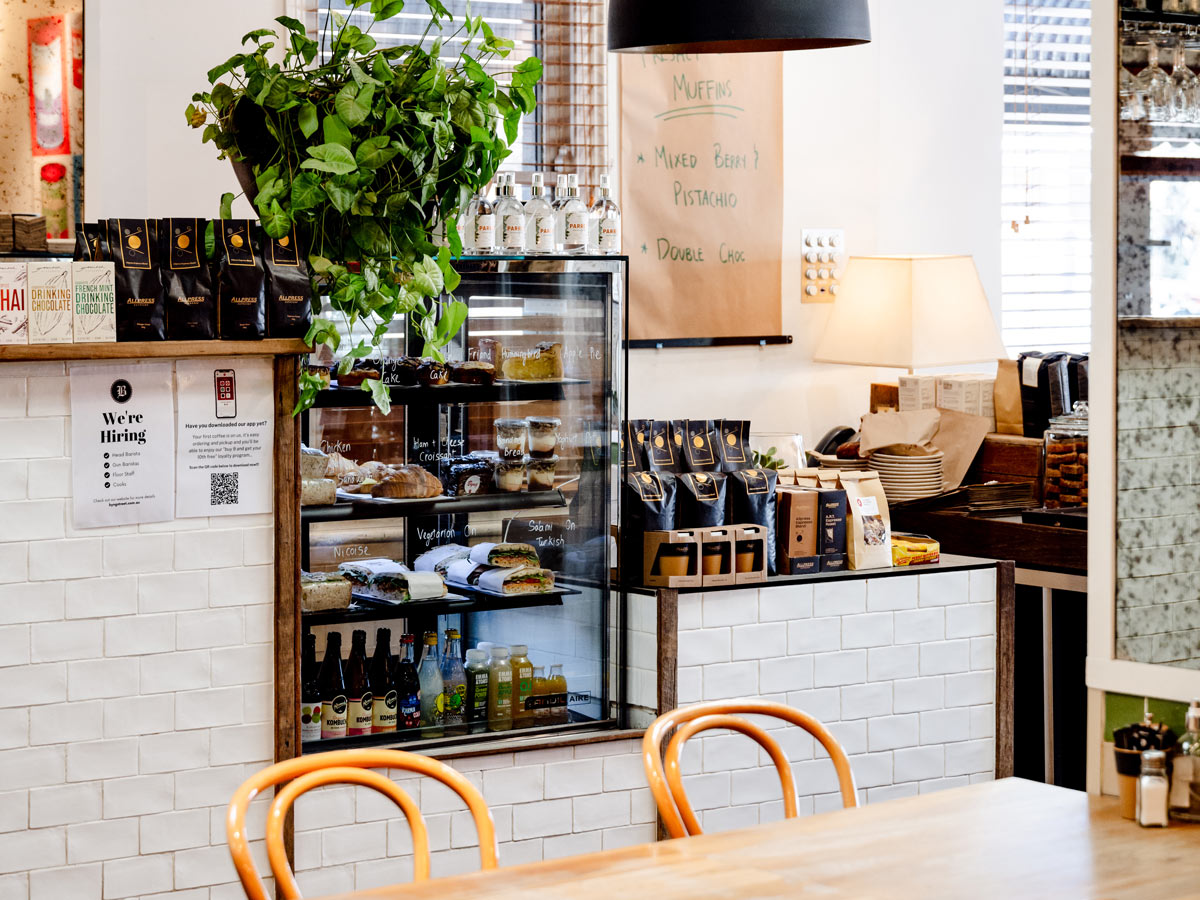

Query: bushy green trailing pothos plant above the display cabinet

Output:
[187, 0, 541, 413]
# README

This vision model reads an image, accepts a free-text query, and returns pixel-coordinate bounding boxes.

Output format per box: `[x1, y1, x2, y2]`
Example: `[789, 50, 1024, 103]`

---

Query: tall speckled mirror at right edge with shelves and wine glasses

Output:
[1114, 8, 1200, 668]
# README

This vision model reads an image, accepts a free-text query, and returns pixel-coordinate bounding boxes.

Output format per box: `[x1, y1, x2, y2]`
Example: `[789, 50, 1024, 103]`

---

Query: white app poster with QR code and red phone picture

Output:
[175, 359, 275, 518]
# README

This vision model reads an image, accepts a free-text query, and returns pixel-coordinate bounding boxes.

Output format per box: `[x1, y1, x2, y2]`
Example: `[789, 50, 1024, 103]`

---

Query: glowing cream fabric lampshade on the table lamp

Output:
[815, 256, 1008, 372]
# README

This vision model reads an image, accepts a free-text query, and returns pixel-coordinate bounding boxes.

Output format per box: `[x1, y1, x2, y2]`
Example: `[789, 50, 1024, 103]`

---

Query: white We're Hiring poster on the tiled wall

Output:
[68, 362, 175, 528]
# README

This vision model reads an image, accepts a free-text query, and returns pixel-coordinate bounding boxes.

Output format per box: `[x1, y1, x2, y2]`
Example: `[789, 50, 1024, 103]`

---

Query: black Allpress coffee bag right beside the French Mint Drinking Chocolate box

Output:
[104, 218, 167, 341]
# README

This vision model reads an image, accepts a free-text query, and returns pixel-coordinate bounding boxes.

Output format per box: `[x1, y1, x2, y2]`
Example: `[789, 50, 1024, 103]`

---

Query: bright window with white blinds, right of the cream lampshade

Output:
[1001, 0, 1092, 354]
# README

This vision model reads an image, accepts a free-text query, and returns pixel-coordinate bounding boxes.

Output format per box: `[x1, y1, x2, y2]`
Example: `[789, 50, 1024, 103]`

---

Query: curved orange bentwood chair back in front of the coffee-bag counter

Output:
[642, 700, 858, 838]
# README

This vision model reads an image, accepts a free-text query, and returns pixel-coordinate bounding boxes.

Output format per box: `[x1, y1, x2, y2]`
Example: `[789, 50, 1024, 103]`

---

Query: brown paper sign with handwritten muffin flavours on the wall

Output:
[620, 53, 784, 340]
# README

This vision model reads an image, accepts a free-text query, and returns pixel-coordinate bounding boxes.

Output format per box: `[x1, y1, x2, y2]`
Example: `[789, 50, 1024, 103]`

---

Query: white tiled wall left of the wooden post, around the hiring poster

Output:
[0, 364, 274, 900]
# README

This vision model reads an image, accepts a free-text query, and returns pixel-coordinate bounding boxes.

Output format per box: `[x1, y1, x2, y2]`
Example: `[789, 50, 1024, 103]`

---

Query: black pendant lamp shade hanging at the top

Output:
[608, 0, 871, 53]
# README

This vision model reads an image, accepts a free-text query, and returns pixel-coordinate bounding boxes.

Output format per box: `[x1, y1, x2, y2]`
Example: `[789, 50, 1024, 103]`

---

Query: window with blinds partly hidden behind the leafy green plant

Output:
[308, 0, 611, 197]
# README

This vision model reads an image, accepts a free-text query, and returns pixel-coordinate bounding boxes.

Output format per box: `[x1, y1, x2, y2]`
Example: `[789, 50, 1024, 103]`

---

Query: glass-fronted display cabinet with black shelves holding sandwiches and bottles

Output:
[300, 256, 626, 752]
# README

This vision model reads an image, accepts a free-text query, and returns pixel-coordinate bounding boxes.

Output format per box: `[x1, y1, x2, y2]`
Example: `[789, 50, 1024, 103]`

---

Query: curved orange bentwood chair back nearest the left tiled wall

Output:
[226, 749, 498, 900]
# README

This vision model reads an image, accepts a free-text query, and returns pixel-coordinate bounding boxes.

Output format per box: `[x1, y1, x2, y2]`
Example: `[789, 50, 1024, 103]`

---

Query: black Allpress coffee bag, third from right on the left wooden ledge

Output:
[158, 218, 217, 341]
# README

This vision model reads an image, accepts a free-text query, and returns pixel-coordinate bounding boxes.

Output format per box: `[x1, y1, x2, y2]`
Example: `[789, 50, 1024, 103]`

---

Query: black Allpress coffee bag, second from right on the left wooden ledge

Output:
[214, 218, 266, 341]
